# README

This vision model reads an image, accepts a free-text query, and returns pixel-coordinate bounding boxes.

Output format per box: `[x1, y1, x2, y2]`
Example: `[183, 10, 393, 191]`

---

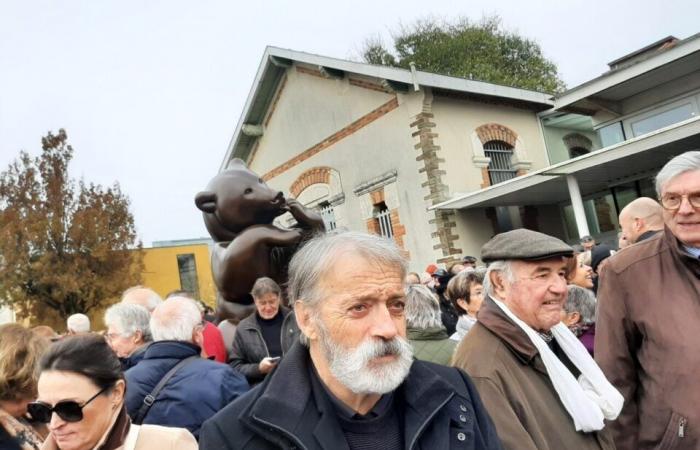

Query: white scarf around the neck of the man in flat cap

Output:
[491, 297, 624, 432]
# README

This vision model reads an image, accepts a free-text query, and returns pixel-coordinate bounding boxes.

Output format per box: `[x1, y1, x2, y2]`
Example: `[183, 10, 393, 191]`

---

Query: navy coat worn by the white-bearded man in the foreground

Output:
[200, 343, 501, 450]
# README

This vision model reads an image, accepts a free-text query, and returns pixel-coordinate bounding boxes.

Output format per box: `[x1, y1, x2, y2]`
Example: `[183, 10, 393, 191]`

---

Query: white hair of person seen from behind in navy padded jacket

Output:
[150, 297, 202, 342]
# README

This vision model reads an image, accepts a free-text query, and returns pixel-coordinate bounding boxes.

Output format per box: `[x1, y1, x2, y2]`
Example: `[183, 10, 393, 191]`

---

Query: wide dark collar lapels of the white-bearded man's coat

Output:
[240, 342, 454, 448]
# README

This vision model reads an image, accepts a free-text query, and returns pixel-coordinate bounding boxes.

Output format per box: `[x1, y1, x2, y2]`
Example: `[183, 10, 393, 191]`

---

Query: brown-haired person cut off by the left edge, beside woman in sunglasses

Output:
[0, 323, 49, 450]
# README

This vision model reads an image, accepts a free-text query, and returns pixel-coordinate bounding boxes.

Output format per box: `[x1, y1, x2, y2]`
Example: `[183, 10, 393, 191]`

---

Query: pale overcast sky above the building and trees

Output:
[0, 0, 700, 245]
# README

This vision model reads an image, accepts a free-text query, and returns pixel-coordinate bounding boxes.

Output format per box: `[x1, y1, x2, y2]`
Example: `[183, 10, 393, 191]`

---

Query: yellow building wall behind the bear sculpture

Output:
[141, 244, 216, 306]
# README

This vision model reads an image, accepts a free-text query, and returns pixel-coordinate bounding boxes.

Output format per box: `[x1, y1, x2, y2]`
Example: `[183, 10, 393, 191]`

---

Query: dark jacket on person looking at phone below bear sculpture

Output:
[229, 306, 299, 384]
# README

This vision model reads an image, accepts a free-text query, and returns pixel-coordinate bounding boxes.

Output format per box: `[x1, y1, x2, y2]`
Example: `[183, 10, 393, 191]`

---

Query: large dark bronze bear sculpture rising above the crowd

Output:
[195, 158, 325, 320]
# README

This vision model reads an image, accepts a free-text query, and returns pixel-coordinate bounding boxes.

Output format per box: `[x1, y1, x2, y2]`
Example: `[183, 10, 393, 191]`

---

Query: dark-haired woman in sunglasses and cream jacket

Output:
[28, 335, 197, 450]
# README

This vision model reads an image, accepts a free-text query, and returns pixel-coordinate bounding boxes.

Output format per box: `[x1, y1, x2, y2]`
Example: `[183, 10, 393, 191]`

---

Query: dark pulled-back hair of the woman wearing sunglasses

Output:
[38, 334, 124, 389]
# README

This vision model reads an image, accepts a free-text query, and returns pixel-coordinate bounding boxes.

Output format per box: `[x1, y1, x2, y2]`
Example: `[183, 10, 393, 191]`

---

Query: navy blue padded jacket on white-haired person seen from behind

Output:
[125, 341, 249, 437]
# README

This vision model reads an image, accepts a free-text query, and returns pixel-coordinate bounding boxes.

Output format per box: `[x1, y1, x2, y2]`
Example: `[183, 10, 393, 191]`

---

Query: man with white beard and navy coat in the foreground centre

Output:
[199, 232, 501, 450]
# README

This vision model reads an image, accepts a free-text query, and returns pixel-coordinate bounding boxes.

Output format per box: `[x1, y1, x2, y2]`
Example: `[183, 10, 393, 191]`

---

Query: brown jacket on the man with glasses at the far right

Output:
[595, 229, 700, 450]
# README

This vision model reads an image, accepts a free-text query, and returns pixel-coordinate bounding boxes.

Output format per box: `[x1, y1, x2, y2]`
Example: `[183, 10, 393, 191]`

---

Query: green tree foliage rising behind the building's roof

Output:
[361, 16, 565, 93]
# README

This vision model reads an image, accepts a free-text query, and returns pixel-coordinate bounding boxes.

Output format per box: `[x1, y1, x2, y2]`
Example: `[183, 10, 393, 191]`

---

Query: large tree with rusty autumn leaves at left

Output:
[0, 129, 142, 321]
